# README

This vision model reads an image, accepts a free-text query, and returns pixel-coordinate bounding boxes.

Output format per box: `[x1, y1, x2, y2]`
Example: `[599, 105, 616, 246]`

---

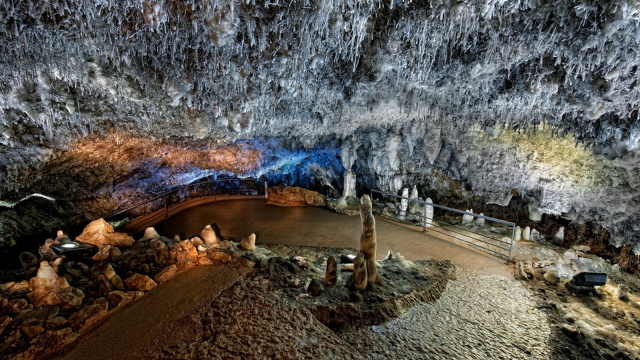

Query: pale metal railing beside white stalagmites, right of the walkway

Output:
[370, 190, 516, 261]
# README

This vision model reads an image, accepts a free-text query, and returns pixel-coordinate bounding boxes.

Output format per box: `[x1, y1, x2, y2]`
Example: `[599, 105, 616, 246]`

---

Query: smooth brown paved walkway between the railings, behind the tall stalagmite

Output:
[155, 199, 513, 277]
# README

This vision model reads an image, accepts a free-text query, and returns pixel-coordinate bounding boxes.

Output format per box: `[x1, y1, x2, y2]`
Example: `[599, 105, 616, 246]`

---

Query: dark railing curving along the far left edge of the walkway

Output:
[107, 178, 267, 222]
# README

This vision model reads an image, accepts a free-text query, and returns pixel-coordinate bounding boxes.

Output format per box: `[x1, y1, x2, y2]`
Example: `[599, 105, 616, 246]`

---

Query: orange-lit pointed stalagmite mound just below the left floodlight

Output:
[29, 261, 84, 308]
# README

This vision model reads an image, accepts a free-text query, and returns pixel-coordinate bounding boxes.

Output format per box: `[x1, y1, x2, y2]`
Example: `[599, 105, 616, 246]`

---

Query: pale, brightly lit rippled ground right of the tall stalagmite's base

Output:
[339, 269, 550, 359]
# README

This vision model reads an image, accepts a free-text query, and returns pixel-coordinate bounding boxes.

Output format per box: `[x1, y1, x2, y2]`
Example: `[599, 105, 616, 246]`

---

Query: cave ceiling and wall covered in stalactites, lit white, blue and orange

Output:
[0, 0, 640, 252]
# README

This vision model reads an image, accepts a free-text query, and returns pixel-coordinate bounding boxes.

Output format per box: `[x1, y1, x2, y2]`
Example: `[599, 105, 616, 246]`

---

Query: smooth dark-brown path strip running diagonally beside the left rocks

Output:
[52, 266, 251, 360]
